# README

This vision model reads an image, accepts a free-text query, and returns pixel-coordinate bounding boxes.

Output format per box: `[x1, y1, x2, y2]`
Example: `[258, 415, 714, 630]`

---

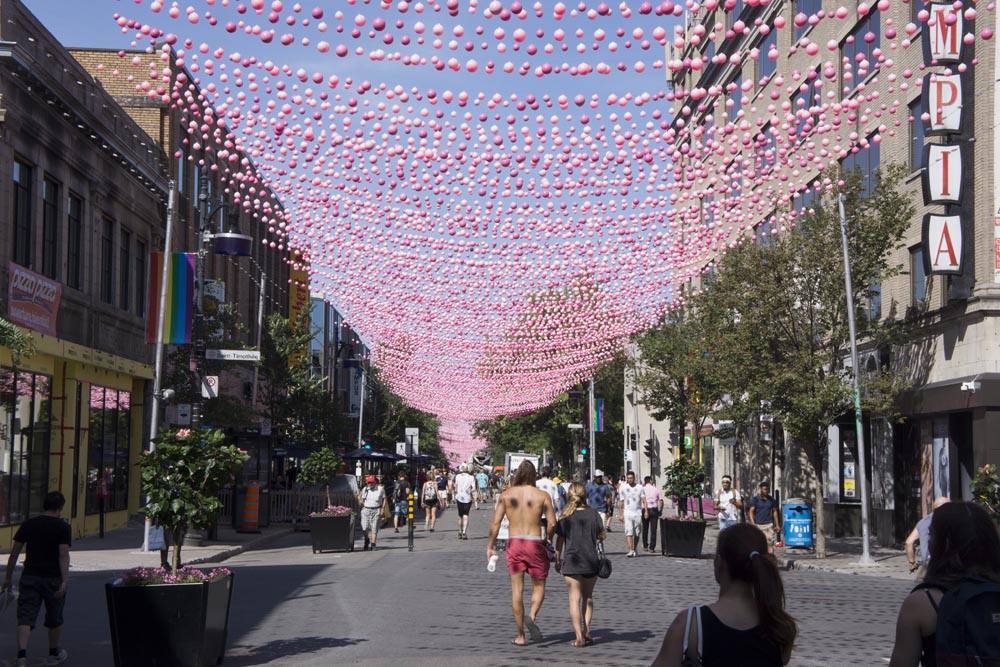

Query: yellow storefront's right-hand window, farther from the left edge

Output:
[86, 385, 132, 514]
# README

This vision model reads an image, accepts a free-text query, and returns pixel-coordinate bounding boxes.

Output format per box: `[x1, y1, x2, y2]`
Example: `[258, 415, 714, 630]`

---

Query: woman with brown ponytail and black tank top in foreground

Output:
[652, 523, 797, 667]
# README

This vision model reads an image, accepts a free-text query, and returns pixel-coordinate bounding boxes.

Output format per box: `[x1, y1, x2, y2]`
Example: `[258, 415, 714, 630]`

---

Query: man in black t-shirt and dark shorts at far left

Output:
[2, 491, 72, 667]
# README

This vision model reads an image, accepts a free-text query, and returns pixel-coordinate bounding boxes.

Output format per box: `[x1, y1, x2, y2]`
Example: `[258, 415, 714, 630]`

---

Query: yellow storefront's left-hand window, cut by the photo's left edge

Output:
[0, 368, 52, 524]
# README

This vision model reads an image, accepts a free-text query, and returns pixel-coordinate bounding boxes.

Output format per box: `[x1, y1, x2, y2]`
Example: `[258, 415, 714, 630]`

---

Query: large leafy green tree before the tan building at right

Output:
[693, 165, 915, 557]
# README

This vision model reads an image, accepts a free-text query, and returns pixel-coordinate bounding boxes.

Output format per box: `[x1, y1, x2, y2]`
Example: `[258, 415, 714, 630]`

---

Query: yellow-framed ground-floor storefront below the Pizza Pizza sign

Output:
[0, 333, 152, 548]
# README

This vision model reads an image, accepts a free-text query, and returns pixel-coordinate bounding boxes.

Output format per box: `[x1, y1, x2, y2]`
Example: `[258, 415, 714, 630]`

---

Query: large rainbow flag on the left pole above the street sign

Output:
[146, 252, 194, 345]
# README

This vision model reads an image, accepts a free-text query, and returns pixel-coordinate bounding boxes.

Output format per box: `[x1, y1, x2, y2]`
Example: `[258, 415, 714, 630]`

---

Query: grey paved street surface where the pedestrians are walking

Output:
[0, 510, 911, 667]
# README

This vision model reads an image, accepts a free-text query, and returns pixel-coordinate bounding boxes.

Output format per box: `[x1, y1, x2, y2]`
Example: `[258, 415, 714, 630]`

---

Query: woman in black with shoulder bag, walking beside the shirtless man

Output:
[556, 482, 605, 648]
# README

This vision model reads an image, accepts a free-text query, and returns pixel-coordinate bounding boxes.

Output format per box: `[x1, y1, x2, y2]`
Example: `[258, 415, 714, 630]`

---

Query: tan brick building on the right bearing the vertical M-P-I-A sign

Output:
[656, 0, 1000, 543]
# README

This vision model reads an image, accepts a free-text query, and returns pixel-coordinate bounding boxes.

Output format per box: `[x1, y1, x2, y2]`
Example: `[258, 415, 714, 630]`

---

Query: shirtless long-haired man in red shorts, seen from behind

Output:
[486, 461, 556, 646]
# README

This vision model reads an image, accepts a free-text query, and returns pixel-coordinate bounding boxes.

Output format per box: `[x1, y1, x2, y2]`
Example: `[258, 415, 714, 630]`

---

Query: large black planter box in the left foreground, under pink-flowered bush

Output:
[105, 576, 233, 667]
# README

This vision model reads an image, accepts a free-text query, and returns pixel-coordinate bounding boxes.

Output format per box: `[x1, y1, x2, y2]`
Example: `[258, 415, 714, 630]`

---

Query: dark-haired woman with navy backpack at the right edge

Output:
[889, 502, 1000, 667]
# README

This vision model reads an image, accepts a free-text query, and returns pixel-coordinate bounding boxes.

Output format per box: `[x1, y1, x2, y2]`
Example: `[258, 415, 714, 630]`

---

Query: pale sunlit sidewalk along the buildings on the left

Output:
[3, 519, 292, 575]
